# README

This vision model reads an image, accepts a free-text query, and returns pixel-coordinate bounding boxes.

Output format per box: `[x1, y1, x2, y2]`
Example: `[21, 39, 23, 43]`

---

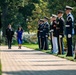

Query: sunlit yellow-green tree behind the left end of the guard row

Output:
[25, 0, 50, 32]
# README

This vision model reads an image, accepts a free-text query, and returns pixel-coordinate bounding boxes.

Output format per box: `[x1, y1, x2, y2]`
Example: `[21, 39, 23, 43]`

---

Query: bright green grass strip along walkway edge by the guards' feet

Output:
[23, 43, 76, 62]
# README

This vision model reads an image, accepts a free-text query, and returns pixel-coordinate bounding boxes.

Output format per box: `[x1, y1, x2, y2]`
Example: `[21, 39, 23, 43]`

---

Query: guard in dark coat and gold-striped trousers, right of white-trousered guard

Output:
[56, 10, 65, 54]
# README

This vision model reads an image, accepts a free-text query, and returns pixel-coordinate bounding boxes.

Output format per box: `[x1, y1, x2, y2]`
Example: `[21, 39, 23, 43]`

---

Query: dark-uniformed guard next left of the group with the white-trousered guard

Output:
[43, 17, 49, 50]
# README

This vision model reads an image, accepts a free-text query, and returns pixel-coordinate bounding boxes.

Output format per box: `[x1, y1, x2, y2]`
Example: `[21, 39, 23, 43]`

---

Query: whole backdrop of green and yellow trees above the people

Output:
[0, 0, 76, 32]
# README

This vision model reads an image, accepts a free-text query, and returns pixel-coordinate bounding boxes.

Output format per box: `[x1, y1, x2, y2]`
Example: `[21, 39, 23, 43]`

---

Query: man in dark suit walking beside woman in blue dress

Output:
[6, 24, 14, 49]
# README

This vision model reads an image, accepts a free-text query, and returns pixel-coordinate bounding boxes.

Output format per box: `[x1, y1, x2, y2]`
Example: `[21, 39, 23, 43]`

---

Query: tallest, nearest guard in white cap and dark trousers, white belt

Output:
[65, 6, 74, 56]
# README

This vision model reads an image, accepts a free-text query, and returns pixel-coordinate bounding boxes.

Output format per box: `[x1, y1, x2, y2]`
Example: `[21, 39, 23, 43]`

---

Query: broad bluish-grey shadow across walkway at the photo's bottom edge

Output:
[2, 70, 76, 75]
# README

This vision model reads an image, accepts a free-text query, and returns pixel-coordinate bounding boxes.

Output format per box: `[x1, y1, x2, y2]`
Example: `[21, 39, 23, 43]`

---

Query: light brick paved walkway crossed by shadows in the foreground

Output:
[0, 46, 76, 75]
